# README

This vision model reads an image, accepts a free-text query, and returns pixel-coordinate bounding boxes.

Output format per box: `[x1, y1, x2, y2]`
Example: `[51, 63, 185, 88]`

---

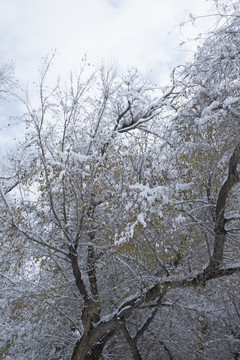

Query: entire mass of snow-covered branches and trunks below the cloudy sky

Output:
[0, 1, 240, 360]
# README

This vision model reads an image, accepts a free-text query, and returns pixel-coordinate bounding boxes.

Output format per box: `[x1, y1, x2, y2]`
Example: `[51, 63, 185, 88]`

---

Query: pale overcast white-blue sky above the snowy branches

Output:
[0, 0, 214, 150]
